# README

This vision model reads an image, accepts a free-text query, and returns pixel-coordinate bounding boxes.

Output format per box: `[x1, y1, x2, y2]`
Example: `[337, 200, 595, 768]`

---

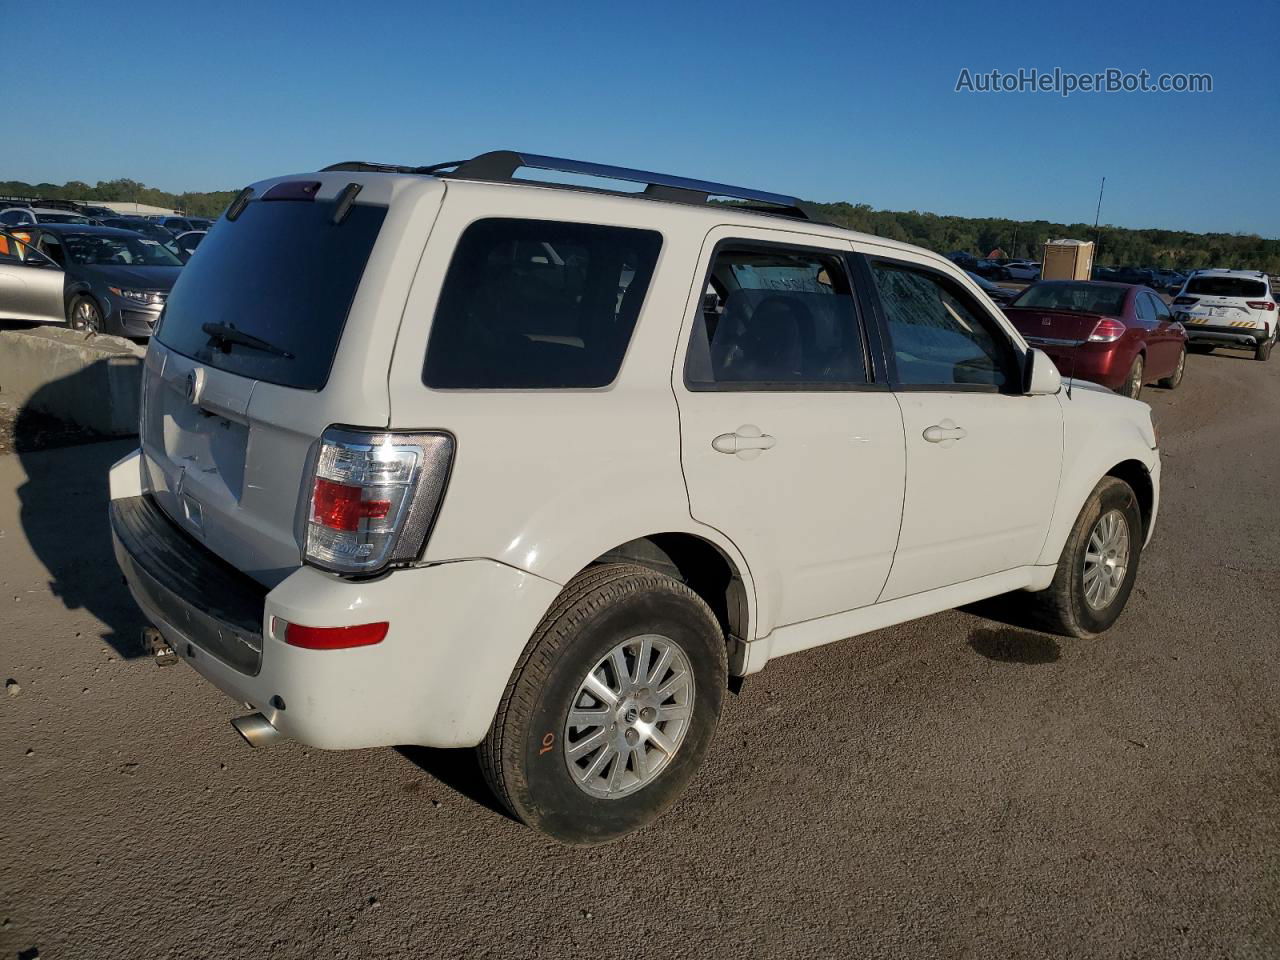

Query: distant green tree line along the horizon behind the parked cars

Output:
[0, 179, 1280, 274]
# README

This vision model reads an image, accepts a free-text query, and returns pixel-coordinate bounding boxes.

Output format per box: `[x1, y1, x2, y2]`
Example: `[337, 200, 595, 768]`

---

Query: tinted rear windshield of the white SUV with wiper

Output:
[156, 200, 387, 390]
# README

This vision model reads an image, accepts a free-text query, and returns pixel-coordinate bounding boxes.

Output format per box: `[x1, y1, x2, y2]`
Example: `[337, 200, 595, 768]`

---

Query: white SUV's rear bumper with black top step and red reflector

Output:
[111, 453, 561, 749]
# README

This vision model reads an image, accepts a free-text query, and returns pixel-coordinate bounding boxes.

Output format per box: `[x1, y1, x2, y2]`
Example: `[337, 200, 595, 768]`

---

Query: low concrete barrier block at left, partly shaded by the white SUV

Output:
[0, 326, 146, 436]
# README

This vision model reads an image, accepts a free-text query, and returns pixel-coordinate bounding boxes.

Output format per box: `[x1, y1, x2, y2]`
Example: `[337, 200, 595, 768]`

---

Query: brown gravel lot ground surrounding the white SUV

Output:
[0, 352, 1280, 960]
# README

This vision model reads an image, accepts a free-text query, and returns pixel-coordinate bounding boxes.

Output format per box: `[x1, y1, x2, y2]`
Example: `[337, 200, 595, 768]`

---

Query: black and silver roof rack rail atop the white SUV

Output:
[324, 150, 814, 220]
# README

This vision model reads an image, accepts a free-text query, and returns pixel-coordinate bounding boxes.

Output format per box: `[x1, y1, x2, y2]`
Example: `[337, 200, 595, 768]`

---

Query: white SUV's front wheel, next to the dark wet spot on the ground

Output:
[1028, 476, 1143, 637]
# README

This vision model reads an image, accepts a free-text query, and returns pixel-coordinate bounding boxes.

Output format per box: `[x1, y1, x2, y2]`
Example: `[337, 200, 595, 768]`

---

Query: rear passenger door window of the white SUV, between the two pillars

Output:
[685, 244, 867, 390]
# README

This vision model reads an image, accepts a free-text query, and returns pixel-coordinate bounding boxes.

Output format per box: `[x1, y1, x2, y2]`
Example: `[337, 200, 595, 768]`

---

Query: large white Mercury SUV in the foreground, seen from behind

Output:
[110, 151, 1160, 842]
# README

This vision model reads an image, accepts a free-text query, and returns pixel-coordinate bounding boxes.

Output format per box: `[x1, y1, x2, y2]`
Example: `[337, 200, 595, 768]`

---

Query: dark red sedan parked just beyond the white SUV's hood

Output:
[1005, 280, 1187, 399]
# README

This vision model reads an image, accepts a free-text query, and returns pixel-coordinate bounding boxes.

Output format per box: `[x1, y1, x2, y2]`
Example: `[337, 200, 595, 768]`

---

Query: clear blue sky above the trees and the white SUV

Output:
[0, 0, 1280, 237]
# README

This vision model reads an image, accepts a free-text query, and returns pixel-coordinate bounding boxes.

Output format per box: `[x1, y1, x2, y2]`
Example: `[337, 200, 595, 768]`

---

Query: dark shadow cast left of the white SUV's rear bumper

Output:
[13, 366, 145, 658]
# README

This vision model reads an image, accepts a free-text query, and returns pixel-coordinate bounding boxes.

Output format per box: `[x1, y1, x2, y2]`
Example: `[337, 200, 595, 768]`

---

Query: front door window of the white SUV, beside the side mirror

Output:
[872, 261, 1018, 388]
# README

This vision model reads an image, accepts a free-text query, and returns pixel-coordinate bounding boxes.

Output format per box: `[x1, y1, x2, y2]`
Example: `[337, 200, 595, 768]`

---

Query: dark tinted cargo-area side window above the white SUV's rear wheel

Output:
[422, 219, 662, 389]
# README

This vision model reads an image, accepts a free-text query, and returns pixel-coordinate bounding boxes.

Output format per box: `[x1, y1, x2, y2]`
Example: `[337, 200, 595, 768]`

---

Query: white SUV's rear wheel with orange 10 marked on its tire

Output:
[479, 563, 728, 845]
